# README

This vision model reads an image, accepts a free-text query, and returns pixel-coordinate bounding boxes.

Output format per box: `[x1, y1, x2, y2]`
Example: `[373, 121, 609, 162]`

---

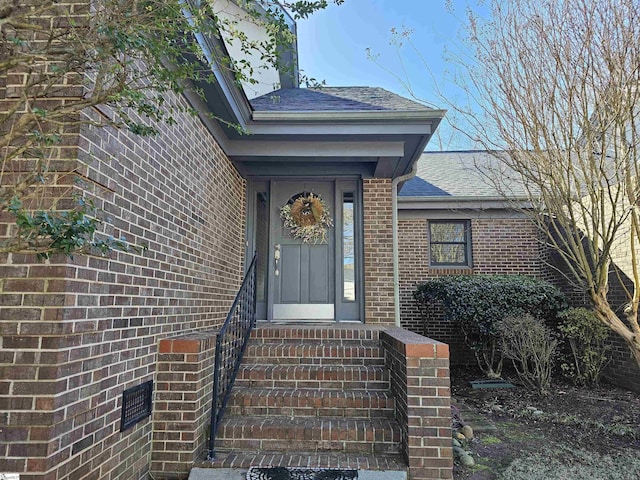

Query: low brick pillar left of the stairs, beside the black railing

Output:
[151, 331, 216, 479]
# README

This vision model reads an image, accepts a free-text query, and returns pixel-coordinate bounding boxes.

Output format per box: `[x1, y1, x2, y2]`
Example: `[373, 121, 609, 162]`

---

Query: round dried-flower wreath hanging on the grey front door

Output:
[280, 192, 333, 243]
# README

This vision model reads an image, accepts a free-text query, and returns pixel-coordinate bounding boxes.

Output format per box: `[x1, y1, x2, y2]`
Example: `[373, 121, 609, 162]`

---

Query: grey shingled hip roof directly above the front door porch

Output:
[251, 87, 432, 112]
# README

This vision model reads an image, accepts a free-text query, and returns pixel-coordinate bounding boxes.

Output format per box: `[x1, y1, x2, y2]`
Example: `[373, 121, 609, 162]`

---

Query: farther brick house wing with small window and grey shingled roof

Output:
[398, 151, 640, 391]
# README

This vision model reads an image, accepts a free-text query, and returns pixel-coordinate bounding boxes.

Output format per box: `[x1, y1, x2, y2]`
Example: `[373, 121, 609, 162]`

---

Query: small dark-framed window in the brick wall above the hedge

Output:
[429, 220, 471, 267]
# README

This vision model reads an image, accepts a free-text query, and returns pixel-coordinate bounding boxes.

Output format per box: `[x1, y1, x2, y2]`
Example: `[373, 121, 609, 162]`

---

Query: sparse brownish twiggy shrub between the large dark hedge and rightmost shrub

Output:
[497, 314, 558, 394]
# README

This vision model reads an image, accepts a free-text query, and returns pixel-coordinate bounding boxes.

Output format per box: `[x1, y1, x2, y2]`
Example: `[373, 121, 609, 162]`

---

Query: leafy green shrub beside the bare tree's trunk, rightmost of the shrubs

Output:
[558, 308, 609, 386]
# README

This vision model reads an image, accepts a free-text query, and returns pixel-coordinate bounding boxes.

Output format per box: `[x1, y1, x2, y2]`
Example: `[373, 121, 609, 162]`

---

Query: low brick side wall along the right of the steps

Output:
[380, 327, 453, 480]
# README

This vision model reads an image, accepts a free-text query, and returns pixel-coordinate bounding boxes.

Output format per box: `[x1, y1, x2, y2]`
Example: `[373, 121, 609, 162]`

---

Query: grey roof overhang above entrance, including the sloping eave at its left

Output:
[187, 31, 445, 178]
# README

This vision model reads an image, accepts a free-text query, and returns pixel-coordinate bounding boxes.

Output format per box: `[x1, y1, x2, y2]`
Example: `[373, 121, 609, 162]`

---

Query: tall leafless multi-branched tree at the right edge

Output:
[452, 0, 640, 366]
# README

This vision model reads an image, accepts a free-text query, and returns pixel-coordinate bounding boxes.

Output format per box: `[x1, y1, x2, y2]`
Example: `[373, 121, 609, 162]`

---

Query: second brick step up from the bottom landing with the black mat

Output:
[227, 387, 395, 418]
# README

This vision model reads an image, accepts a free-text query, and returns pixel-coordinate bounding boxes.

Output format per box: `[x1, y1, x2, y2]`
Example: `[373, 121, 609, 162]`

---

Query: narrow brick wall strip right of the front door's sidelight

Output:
[362, 178, 395, 325]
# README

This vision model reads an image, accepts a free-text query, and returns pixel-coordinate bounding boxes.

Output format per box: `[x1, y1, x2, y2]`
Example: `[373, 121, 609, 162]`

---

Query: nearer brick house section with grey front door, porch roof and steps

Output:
[0, 0, 452, 480]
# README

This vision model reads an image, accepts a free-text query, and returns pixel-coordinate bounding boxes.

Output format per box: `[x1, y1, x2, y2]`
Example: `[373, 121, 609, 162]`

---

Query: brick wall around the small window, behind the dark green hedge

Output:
[398, 217, 544, 364]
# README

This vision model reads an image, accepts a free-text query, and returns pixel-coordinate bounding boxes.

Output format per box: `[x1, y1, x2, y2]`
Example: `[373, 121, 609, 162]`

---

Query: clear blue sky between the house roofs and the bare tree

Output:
[298, 0, 484, 150]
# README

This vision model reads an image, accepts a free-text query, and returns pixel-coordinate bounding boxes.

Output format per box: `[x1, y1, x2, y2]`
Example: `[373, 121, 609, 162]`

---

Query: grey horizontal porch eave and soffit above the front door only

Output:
[227, 111, 444, 178]
